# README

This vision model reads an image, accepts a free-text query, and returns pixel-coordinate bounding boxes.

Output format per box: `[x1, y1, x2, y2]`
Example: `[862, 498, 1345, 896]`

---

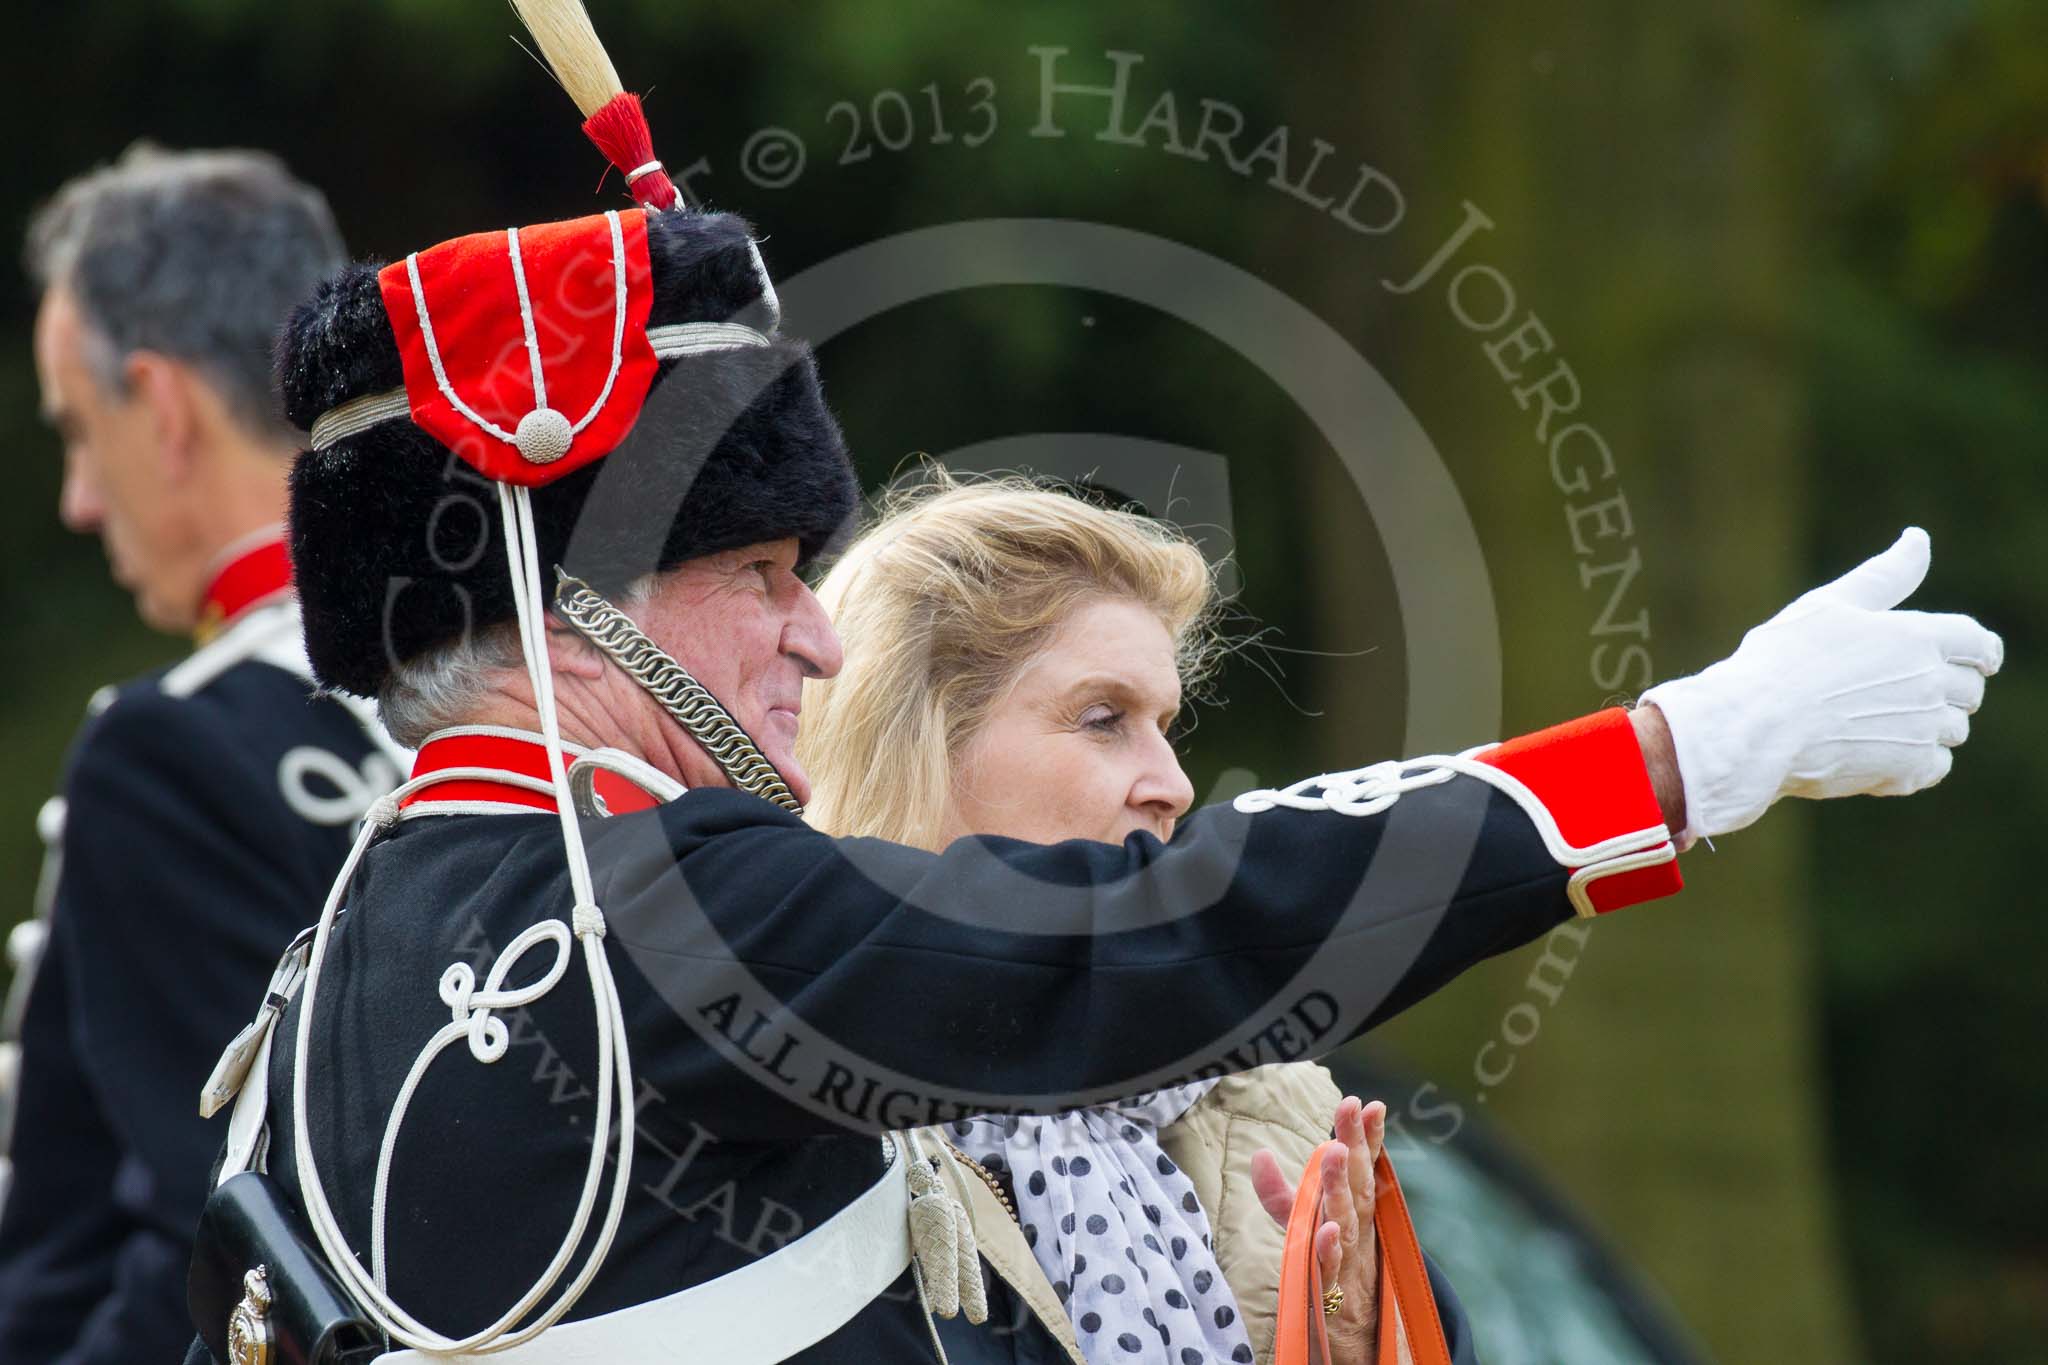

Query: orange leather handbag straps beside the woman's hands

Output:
[1274, 1142, 1450, 1365]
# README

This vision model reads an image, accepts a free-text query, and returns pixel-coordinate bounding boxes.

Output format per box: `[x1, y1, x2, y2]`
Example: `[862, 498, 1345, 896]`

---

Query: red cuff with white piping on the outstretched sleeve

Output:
[1473, 706, 1686, 915]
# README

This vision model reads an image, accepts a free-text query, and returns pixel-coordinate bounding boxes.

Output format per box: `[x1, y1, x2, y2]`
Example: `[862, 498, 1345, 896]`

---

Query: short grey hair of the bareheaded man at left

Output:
[25, 143, 348, 438]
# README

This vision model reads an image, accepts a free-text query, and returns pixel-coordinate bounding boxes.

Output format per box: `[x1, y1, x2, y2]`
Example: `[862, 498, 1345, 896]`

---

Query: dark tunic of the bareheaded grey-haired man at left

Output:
[0, 622, 397, 1365]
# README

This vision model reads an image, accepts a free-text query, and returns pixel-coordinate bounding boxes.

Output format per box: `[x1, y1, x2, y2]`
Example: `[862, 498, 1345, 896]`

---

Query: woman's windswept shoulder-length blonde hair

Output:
[797, 471, 1214, 847]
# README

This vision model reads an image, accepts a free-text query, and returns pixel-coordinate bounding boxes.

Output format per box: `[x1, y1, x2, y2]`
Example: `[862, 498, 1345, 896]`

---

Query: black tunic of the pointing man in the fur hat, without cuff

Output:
[256, 767, 1597, 1363]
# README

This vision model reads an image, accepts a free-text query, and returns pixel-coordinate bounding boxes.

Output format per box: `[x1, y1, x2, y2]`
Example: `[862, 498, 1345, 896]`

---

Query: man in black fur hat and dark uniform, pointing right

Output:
[193, 13, 1999, 1365]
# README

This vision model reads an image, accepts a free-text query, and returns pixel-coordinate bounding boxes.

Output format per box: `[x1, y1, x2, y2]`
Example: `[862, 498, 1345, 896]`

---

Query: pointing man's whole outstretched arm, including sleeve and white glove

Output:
[610, 532, 2001, 1136]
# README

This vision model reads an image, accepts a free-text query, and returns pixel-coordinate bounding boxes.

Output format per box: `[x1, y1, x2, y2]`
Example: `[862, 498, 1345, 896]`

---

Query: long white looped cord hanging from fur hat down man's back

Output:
[291, 485, 633, 1355]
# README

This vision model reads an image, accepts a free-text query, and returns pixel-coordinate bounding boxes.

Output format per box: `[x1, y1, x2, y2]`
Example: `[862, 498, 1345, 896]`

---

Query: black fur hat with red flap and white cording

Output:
[279, 209, 858, 696]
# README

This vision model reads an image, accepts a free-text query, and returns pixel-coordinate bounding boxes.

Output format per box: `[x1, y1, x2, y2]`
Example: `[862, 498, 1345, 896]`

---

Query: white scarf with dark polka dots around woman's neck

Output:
[948, 1081, 1251, 1365]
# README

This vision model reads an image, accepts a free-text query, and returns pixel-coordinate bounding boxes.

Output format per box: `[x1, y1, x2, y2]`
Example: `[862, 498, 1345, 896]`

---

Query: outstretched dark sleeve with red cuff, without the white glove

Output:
[626, 710, 1677, 1138]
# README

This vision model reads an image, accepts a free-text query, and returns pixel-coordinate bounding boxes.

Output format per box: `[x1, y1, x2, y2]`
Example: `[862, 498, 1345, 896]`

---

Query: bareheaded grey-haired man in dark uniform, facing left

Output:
[0, 147, 406, 1365]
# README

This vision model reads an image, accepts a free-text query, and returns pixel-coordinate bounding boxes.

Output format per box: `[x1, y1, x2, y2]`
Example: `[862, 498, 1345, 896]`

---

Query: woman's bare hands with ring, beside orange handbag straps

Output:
[1251, 1095, 1386, 1365]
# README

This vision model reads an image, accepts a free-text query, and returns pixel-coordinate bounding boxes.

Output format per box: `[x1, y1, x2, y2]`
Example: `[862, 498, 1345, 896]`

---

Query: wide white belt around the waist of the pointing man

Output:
[377, 1138, 909, 1365]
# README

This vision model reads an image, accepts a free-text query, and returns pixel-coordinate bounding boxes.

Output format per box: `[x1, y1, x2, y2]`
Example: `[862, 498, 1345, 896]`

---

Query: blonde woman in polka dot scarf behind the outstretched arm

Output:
[797, 479, 1417, 1365]
